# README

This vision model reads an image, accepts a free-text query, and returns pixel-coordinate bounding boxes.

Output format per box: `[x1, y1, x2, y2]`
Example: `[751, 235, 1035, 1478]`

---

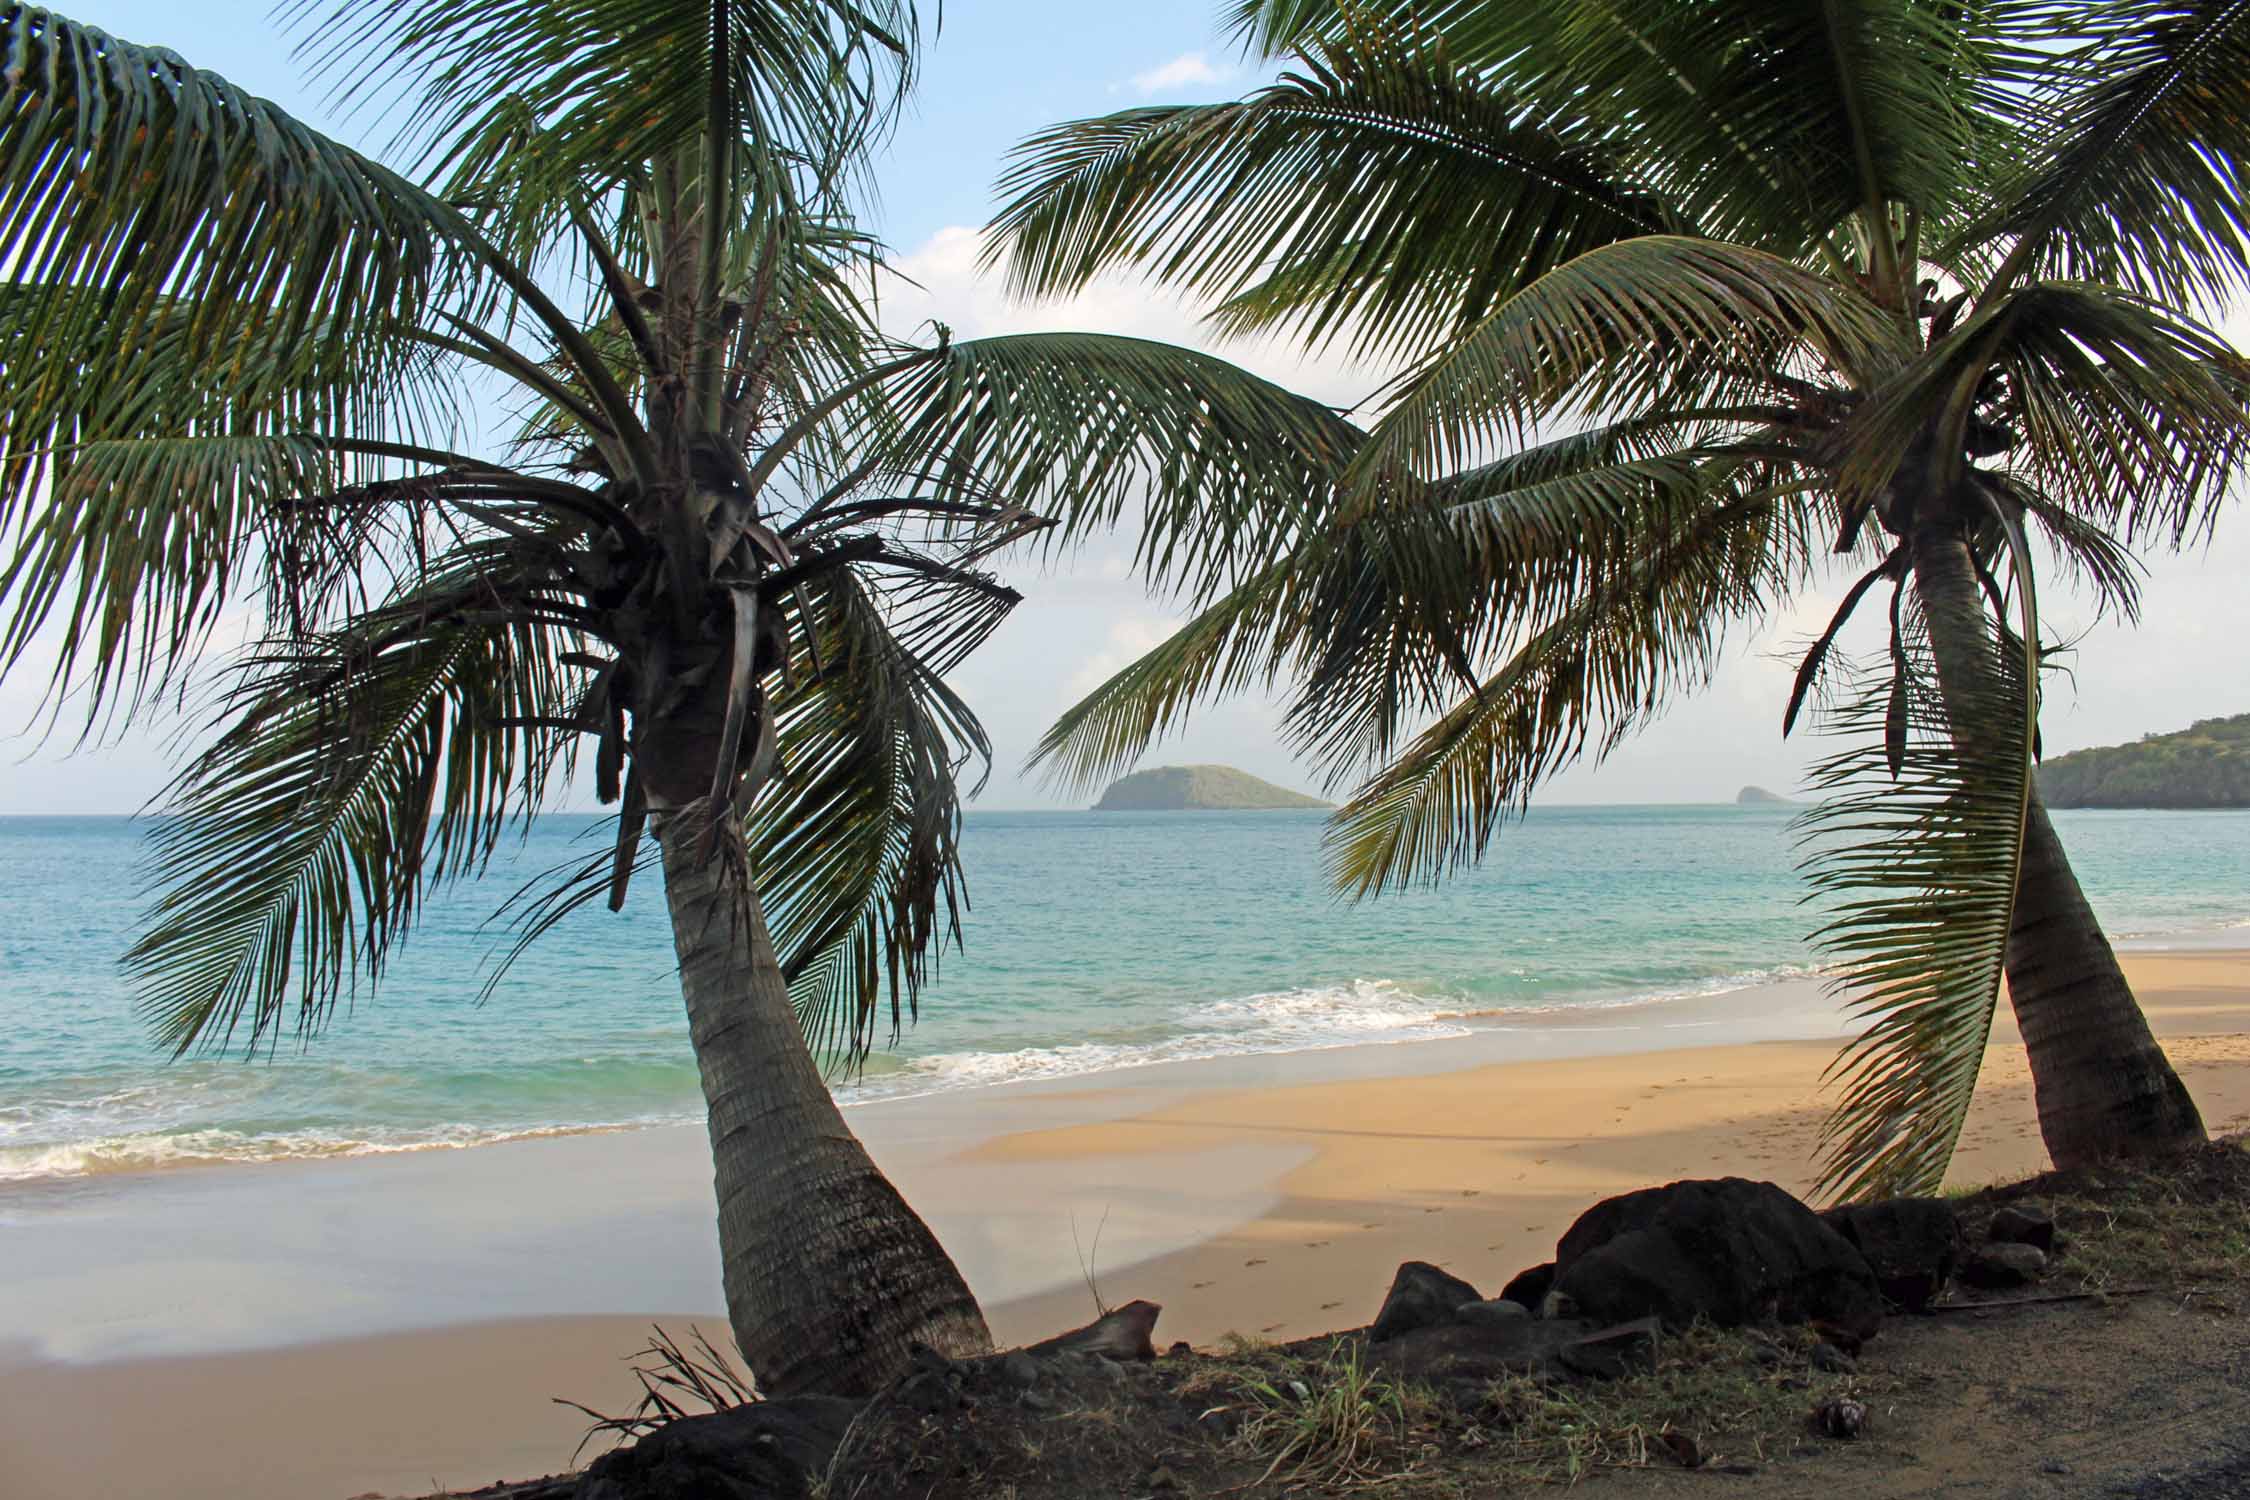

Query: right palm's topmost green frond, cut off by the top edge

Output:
[1233, 0, 1994, 259]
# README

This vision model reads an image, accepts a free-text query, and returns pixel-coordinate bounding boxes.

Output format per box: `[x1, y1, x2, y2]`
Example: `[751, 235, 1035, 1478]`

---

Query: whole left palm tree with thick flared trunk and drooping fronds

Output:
[0, 0, 1348, 1392]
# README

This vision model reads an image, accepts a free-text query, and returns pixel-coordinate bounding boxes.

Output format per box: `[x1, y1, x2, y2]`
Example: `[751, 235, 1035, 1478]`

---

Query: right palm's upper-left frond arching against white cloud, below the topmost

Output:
[986, 31, 1685, 364]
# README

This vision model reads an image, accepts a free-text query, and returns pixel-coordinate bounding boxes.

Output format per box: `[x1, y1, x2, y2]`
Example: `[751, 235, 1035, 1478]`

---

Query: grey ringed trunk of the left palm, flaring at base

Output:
[657, 814, 992, 1397]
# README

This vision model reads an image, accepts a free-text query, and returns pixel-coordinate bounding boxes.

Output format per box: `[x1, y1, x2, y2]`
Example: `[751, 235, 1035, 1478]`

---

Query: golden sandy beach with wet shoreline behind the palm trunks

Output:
[0, 949, 2250, 1500]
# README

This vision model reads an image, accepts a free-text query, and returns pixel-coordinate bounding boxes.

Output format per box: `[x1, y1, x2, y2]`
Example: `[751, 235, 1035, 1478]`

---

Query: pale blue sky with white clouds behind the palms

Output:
[0, 0, 2250, 814]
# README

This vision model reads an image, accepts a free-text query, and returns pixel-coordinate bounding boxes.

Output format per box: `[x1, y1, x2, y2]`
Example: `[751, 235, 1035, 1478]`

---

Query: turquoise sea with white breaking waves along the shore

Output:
[0, 807, 2250, 1181]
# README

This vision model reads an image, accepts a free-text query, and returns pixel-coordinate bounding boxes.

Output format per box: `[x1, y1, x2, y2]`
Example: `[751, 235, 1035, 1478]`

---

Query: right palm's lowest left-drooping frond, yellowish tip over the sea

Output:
[1325, 495, 1809, 897]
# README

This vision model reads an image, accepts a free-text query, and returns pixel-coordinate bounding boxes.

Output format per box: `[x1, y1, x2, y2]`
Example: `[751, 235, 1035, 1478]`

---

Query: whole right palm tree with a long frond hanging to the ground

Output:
[990, 0, 2250, 1192]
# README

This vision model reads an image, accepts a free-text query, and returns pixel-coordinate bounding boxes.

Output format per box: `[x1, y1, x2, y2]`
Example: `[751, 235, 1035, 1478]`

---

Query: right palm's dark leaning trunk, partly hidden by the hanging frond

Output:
[1915, 528, 2205, 1167]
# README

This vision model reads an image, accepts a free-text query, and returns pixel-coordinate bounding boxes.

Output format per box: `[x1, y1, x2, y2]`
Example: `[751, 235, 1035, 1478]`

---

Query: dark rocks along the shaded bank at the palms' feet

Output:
[574, 1178, 2057, 1500]
